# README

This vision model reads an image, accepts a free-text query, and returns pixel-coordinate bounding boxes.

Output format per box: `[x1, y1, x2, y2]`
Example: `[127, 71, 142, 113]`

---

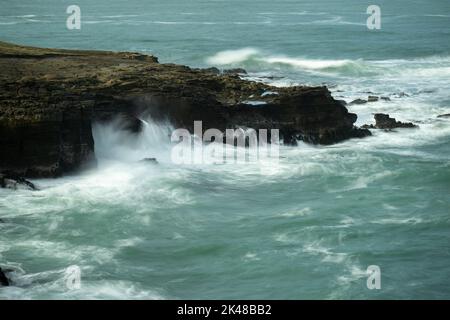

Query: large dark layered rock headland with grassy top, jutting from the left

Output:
[0, 42, 370, 177]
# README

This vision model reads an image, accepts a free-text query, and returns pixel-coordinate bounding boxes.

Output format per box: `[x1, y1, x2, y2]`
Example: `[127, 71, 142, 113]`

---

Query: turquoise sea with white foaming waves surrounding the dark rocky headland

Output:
[0, 0, 450, 299]
